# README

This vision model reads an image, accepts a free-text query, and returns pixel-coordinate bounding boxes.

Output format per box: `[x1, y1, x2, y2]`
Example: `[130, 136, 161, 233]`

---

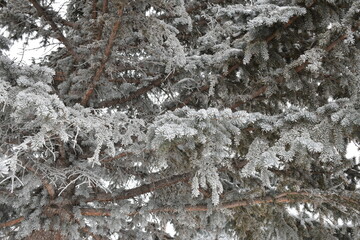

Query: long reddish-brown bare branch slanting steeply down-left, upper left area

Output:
[81, 6, 124, 106]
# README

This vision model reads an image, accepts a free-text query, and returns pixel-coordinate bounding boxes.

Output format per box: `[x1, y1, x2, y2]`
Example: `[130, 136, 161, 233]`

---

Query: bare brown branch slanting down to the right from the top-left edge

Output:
[29, 0, 80, 62]
